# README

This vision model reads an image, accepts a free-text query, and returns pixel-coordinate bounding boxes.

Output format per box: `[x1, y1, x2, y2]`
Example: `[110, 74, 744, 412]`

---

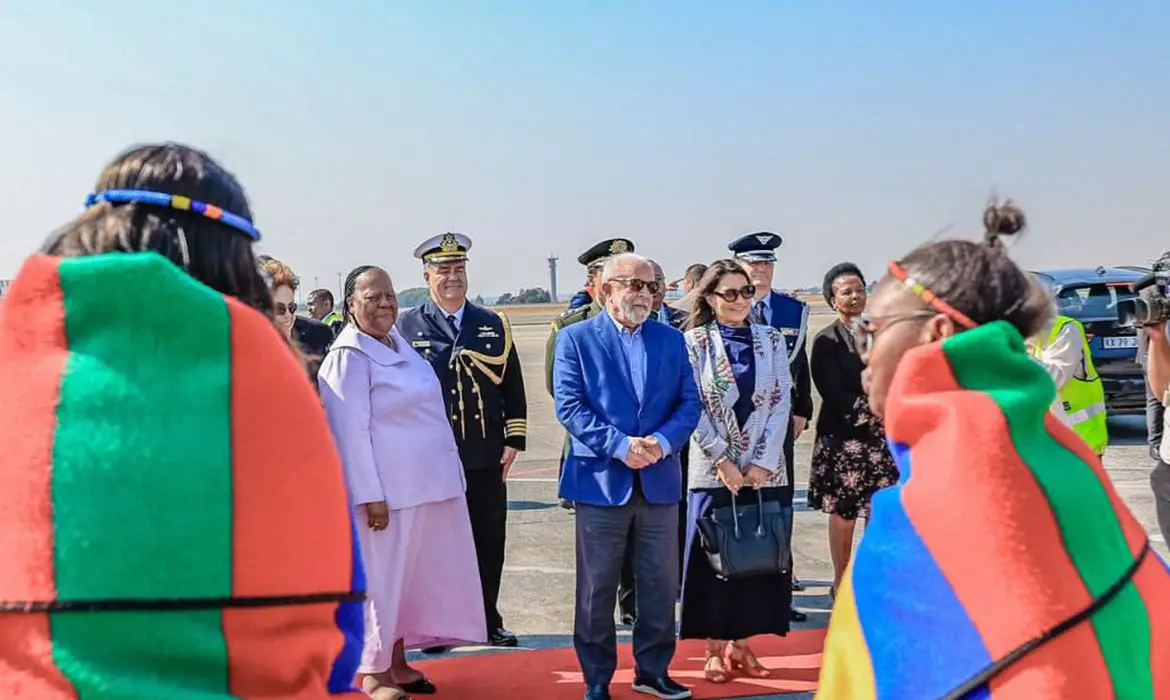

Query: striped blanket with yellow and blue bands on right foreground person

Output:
[817, 323, 1170, 700]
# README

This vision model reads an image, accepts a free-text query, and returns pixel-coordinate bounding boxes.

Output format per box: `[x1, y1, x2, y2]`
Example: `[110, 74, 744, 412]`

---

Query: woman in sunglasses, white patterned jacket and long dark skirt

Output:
[679, 260, 792, 682]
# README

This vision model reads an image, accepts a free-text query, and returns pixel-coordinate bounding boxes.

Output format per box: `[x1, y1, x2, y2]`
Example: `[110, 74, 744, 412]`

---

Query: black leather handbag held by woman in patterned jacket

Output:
[697, 489, 792, 581]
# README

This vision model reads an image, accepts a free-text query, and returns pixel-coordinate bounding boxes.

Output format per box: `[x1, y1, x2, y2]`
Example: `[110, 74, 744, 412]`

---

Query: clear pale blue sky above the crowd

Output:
[0, 0, 1170, 295]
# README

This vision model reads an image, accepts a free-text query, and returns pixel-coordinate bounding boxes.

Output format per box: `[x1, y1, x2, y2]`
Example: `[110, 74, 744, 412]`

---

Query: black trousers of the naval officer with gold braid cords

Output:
[466, 469, 508, 632]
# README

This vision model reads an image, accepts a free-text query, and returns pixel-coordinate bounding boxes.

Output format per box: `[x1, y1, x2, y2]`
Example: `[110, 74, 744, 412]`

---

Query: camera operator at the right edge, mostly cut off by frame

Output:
[1138, 289, 1170, 543]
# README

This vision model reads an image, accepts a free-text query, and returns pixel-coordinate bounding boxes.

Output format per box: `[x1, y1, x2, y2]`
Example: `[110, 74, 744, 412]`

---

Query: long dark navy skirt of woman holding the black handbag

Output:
[679, 488, 792, 640]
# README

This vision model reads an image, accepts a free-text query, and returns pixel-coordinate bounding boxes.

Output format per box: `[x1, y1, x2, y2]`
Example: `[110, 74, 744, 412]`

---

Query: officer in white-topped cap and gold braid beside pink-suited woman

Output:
[398, 233, 528, 651]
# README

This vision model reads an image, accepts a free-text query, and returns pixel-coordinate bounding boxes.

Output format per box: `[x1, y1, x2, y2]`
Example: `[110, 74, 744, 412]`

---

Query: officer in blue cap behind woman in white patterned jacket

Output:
[728, 231, 812, 622]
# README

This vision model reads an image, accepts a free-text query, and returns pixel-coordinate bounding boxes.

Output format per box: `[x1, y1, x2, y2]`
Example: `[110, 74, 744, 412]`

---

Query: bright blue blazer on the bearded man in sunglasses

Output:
[552, 311, 702, 506]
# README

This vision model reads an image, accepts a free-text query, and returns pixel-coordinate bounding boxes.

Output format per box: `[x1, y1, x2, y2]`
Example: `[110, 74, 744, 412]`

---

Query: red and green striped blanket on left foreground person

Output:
[0, 254, 365, 700]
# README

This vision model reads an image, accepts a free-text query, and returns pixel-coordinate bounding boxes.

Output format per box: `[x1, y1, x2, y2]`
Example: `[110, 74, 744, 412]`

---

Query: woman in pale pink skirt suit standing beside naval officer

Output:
[318, 266, 487, 698]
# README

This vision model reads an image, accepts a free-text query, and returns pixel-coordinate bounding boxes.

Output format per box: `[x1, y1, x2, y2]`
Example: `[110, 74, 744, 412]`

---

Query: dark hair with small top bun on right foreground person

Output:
[899, 200, 1053, 337]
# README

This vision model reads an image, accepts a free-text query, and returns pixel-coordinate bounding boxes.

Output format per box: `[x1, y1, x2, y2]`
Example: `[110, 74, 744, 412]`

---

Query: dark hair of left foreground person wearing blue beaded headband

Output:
[41, 143, 273, 317]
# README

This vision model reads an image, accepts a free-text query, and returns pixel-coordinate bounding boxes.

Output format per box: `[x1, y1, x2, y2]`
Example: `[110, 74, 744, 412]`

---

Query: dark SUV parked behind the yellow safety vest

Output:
[1032, 267, 1149, 414]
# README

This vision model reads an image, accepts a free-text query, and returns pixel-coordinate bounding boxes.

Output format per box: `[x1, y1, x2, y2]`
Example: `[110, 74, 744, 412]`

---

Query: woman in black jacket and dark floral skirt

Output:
[808, 262, 897, 596]
